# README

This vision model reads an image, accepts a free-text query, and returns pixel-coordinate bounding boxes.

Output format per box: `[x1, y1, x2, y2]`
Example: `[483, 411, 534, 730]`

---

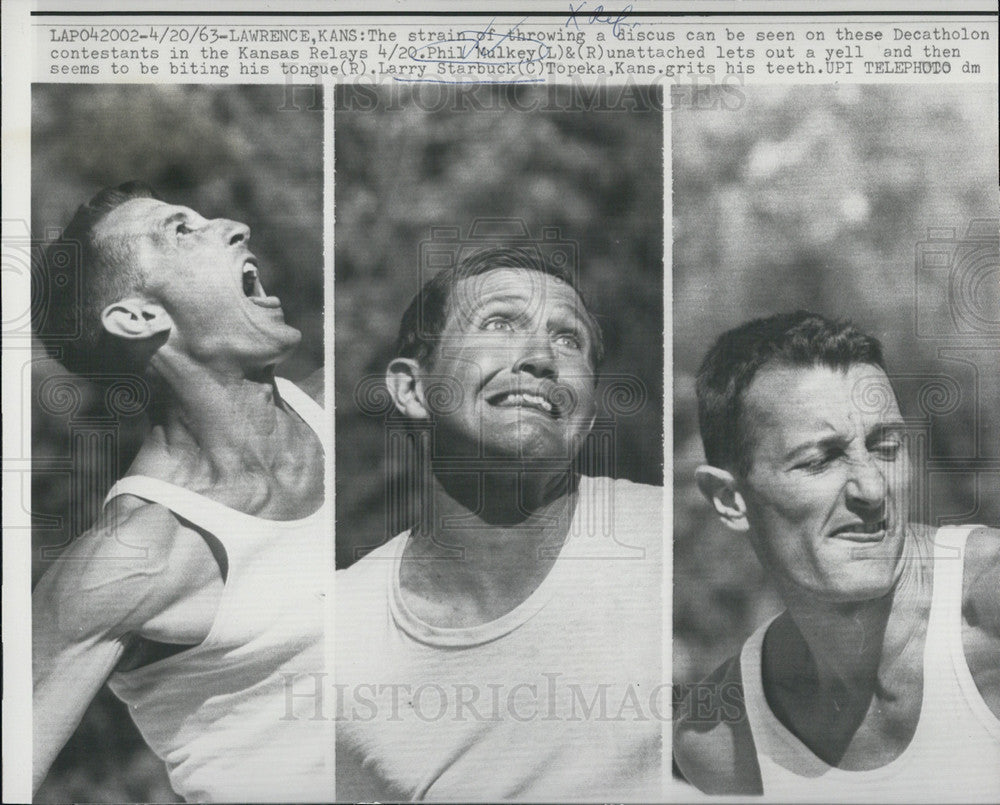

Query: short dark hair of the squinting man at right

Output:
[696, 310, 885, 477]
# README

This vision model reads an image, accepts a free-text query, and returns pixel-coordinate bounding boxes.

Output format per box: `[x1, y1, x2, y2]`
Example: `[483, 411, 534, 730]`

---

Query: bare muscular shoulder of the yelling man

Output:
[32, 496, 219, 637]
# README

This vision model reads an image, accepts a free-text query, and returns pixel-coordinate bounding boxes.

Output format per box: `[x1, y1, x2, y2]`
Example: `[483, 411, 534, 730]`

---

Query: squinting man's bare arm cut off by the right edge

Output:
[962, 528, 1000, 718]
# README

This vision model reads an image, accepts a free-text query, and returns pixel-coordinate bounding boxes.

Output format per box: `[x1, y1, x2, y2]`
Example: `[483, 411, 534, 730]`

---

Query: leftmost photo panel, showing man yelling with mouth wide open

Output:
[25, 85, 333, 802]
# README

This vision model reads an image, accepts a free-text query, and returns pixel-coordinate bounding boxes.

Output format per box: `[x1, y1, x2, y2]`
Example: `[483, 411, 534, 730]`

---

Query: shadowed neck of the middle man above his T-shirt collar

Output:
[400, 468, 577, 627]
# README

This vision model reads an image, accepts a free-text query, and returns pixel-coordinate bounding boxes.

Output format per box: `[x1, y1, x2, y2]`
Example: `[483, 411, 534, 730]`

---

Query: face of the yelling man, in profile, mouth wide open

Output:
[94, 198, 301, 366]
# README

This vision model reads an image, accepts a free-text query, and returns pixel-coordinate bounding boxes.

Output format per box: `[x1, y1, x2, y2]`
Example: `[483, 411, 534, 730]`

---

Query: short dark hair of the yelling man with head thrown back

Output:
[33, 181, 160, 373]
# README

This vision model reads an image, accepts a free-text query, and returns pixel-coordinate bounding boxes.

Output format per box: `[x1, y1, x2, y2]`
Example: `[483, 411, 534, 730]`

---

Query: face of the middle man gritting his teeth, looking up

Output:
[425, 268, 595, 460]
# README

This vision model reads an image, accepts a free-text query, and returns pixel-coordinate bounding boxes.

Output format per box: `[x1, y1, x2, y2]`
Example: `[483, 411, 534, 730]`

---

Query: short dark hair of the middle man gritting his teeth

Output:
[395, 246, 604, 379]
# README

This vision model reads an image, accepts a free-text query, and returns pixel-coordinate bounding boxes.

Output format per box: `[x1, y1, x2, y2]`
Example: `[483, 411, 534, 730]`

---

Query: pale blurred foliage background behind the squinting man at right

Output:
[672, 84, 1000, 683]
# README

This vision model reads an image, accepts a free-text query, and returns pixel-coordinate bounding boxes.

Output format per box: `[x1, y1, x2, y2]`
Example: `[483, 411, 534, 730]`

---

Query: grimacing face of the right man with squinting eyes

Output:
[738, 364, 909, 602]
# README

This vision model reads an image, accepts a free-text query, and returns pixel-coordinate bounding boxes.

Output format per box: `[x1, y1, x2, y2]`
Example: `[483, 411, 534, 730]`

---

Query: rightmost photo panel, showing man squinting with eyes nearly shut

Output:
[672, 84, 1000, 802]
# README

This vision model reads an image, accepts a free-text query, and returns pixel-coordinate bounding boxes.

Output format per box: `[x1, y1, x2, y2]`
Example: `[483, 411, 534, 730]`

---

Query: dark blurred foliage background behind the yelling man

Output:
[31, 84, 323, 802]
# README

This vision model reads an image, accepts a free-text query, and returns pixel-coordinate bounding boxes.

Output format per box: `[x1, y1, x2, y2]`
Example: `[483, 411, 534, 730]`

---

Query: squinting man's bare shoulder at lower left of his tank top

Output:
[674, 656, 763, 794]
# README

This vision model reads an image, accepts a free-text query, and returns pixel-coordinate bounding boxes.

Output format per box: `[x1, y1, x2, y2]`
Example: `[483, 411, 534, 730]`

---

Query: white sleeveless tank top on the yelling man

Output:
[105, 379, 334, 802]
